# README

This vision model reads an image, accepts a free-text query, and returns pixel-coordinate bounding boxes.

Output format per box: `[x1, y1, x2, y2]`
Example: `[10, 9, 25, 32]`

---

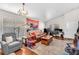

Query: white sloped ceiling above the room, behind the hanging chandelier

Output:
[0, 3, 79, 21]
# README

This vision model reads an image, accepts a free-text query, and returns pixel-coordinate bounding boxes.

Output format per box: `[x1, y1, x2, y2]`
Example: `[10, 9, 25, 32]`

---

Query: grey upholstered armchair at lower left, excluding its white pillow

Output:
[1, 33, 22, 54]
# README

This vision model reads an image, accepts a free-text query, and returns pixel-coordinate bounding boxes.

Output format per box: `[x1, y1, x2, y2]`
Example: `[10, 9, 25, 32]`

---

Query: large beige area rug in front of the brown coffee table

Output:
[29, 39, 72, 55]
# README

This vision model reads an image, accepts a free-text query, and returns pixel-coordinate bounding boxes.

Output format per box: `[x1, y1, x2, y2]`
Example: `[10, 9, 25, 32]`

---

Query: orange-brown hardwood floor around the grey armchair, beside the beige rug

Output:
[0, 45, 37, 55]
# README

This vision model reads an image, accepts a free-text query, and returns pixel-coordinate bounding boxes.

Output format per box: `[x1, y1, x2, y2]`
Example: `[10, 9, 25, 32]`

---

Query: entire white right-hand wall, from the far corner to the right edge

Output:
[46, 9, 79, 38]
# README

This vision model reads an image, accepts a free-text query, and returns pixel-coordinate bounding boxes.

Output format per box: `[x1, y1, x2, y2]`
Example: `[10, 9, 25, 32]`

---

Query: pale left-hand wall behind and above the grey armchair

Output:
[0, 9, 25, 48]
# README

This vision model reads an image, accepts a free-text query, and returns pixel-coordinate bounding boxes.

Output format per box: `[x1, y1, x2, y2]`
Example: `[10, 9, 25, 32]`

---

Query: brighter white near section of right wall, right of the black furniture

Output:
[64, 9, 79, 38]
